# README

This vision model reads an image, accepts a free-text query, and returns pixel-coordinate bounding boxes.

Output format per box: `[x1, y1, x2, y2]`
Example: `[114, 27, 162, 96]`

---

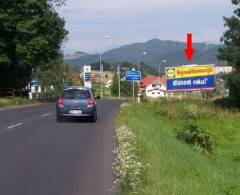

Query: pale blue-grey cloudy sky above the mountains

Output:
[58, 0, 235, 54]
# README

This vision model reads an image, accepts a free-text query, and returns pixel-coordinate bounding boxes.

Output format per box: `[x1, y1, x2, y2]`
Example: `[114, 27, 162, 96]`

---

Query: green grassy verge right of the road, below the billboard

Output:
[117, 101, 240, 195]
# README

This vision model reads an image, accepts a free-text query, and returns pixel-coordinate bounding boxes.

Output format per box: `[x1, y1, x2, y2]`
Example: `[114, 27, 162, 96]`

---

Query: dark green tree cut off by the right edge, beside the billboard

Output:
[218, 0, 240, 73]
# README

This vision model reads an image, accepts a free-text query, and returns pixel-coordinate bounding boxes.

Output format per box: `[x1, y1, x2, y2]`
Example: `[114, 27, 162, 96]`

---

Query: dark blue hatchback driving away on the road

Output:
[56, 87, 97, 122]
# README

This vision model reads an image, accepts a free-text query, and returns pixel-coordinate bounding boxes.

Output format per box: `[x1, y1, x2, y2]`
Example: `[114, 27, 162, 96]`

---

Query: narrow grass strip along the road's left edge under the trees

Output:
[0, 98, 37, 108]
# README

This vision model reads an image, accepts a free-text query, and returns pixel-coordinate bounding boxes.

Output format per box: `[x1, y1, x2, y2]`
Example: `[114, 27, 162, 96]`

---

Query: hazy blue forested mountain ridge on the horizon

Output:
[64, 39, 226, 67]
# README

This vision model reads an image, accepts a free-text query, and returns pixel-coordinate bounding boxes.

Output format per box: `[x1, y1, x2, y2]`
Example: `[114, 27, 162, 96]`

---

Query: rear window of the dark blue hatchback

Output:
[62, 89, 91, 99]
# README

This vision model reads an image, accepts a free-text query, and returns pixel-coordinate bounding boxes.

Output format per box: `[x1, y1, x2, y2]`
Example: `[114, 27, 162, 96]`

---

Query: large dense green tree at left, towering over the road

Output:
[0, 0, 67, 88]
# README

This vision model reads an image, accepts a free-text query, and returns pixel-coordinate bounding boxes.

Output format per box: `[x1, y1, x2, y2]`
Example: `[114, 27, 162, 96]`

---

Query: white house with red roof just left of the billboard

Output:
[140, 76, 167, 98]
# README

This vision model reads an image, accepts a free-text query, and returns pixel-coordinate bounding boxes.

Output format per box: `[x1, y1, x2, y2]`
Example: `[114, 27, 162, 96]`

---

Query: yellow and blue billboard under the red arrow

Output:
[165, 65, 215, 91]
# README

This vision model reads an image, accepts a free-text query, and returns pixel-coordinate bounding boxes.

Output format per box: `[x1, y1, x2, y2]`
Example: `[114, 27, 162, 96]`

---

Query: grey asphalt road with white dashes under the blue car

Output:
[0, 100, 121, 195]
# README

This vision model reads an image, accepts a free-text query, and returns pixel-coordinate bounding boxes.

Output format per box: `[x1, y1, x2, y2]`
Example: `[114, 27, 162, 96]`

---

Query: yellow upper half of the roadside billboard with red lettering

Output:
[166, 65, 215, 79]
